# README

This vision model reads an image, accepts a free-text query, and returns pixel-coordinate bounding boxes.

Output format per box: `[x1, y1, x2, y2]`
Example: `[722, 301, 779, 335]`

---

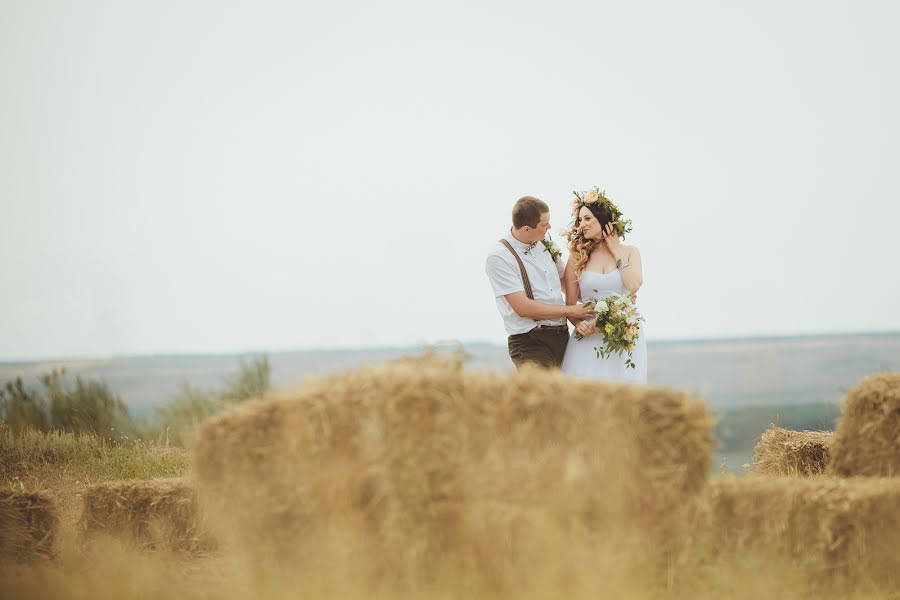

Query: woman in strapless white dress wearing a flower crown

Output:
[561, 189, 647, 383]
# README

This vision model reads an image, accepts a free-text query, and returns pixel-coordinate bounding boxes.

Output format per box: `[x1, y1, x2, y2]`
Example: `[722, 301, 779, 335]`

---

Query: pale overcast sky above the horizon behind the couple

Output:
[0, 0, 900, 360]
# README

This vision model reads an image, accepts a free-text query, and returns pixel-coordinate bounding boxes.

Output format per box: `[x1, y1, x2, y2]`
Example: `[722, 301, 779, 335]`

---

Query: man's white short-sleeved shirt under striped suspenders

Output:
[484, 233, 566, 335]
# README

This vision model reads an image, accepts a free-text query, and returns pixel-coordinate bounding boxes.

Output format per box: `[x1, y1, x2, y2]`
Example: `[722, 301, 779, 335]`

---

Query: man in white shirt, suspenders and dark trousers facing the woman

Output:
[484, 196, 594, 368]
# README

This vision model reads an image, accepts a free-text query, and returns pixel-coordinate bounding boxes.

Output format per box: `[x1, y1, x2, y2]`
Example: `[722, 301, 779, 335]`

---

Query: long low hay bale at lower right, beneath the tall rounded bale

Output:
[698, 477, 900, 589]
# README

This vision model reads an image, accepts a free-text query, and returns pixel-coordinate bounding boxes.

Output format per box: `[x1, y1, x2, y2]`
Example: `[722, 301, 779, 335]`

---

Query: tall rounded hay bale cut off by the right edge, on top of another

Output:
[829, 373, 900, 477]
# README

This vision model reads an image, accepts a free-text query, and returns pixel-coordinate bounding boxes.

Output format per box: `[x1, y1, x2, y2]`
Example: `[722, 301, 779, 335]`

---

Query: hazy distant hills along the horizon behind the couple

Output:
[0, 334, 900, 416]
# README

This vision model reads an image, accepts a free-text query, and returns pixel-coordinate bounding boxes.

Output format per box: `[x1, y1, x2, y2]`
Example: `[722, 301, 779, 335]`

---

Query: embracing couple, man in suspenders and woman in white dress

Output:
[485, 188, 647, 383]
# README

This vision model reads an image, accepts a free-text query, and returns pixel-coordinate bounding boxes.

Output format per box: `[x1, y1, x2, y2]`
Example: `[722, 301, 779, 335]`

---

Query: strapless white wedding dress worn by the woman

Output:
[561, 269, 647, 383]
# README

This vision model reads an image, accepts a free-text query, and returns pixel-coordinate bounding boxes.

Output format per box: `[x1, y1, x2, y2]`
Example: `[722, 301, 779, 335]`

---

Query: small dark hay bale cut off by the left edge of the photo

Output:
[0, 490, 59, 561]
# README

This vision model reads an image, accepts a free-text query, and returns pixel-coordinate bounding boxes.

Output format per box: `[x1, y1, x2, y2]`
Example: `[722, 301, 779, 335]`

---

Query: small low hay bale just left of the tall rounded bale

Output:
[753, 425, 832, 477]
